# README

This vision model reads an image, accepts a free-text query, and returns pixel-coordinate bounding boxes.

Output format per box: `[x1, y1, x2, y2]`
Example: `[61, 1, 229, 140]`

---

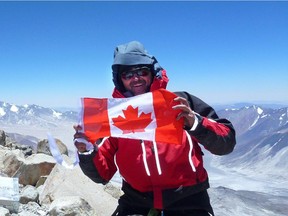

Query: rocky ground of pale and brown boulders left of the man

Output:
[0, 131, 121, 216]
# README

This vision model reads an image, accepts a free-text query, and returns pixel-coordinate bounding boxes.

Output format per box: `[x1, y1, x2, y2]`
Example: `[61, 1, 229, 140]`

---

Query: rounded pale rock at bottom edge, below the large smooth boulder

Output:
[49, 196, 96, 216]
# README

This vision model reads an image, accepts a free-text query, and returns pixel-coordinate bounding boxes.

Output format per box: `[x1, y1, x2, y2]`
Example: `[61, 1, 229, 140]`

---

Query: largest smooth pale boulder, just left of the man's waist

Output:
[39, 164, 118, 216]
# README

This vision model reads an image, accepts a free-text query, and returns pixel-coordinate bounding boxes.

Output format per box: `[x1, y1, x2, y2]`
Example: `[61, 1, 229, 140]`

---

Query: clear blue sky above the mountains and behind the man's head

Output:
[0, 1, 288, 107]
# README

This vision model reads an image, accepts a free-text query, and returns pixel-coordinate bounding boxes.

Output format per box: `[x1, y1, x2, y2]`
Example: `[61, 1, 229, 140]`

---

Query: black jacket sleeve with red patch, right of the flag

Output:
[175, 92, 236, 155]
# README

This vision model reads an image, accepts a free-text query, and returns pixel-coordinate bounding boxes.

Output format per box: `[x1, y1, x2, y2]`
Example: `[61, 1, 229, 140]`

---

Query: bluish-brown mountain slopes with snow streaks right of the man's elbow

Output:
[218, 105, 288, 177]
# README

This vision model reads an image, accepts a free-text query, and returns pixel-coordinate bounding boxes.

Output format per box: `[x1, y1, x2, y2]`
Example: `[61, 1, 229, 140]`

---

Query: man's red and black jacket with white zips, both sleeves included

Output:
[79, 70, 236, 212]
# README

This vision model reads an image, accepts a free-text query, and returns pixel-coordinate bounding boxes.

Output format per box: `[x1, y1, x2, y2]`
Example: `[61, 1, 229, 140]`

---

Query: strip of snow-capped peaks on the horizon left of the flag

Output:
[0, 101, 78, 127]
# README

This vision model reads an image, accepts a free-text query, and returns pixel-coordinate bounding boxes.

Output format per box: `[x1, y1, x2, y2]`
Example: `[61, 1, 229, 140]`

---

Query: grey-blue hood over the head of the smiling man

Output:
[112, 41, 166, 93]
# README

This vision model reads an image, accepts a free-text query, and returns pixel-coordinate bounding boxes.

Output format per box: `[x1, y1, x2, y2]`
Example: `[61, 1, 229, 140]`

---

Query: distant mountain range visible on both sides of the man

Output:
[0, 102, 288, 177]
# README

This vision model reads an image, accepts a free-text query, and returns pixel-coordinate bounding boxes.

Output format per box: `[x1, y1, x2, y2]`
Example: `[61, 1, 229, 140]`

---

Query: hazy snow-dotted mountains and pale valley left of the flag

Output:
[0, 101, 79, 147]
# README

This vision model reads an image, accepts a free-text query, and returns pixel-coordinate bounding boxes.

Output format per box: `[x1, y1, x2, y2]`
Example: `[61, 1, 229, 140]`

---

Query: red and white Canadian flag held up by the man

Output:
[80, 89, 184, 144]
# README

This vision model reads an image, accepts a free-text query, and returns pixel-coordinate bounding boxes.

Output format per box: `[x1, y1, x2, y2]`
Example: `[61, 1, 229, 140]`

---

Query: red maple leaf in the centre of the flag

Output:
[112, 105, 152, 134]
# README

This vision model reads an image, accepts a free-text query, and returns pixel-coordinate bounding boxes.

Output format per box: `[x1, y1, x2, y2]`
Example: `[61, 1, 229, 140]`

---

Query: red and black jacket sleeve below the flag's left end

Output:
[78, 138, 117, 185]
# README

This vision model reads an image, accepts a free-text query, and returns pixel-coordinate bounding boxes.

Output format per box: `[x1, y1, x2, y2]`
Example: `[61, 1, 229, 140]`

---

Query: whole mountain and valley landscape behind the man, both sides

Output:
[0, 102, 288, 216]
